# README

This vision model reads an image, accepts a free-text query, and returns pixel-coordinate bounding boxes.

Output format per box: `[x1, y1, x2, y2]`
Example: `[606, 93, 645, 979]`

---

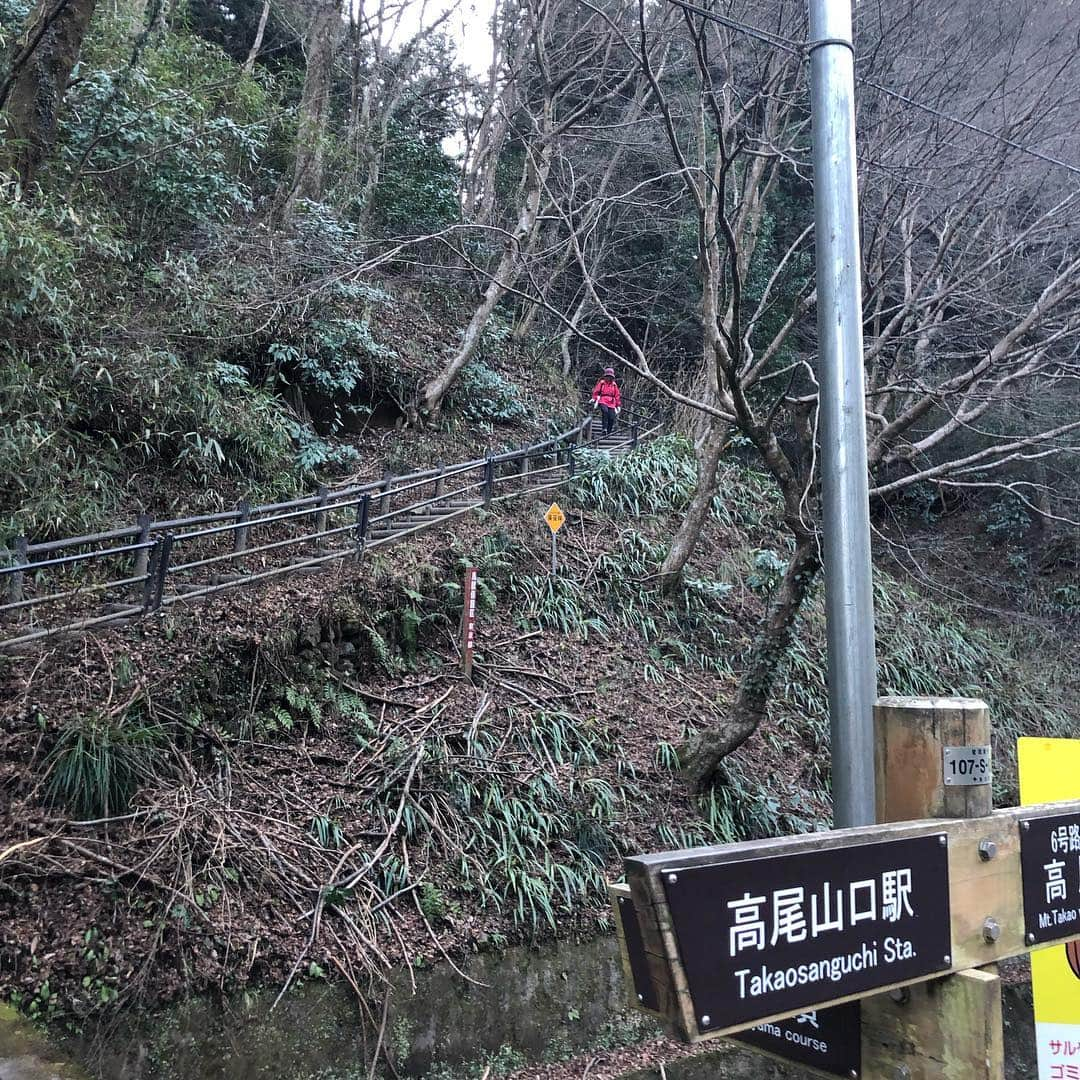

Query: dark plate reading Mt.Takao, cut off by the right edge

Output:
[1020, 813, 1080, 945]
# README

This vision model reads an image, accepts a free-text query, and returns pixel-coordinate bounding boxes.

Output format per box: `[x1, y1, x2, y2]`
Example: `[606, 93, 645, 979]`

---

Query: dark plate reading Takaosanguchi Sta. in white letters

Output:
[661, 834, 951, 1035]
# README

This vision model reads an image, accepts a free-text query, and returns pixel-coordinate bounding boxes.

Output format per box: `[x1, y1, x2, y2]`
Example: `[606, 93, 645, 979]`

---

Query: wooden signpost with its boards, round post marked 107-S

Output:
[612, 698, 1080, 1080]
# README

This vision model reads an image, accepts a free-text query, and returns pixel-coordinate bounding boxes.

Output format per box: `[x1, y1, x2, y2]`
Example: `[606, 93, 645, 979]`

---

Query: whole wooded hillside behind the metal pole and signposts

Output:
[0, 0, 1080, 1075]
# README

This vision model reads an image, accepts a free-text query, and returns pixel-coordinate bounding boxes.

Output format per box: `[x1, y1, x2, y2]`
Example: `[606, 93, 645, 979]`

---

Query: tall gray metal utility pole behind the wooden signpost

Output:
[808, 0, 877, 828]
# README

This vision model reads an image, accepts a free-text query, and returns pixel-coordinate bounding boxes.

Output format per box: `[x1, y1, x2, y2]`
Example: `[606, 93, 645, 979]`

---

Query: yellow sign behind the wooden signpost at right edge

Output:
[1016, 739, 1080, 1080]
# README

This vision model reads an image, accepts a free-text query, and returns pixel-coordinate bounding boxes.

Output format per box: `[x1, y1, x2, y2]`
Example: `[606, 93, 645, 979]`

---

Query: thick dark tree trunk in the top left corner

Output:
[0, 0, 96, 191]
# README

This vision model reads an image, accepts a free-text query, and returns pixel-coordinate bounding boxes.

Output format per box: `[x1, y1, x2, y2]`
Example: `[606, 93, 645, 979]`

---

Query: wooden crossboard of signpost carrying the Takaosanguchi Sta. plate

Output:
[626, 801, 1080, 1042]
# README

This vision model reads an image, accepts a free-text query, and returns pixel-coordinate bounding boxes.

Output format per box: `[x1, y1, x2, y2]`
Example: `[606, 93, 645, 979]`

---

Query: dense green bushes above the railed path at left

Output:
[0, 22, 552, 546]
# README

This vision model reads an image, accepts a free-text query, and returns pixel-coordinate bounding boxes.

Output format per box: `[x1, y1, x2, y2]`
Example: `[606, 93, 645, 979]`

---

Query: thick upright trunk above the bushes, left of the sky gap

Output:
[285, 0, 341, 217]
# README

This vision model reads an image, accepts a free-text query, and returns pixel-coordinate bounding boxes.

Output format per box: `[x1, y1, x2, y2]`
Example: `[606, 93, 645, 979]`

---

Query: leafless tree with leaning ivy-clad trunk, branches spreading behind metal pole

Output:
[561, 3, 1080, 783]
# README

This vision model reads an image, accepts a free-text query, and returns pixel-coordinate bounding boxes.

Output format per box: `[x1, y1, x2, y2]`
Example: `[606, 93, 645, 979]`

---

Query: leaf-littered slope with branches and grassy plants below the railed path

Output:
[0, 427, 1070, 1045]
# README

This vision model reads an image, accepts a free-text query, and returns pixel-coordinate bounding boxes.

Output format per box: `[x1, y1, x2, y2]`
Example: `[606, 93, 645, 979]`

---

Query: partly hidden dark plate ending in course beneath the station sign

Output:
[731, 1001, 863, 1080]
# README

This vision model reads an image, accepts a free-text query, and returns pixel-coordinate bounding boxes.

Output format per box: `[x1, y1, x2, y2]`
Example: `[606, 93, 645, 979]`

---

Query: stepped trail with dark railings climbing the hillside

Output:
[0, 405, 660, 651]
